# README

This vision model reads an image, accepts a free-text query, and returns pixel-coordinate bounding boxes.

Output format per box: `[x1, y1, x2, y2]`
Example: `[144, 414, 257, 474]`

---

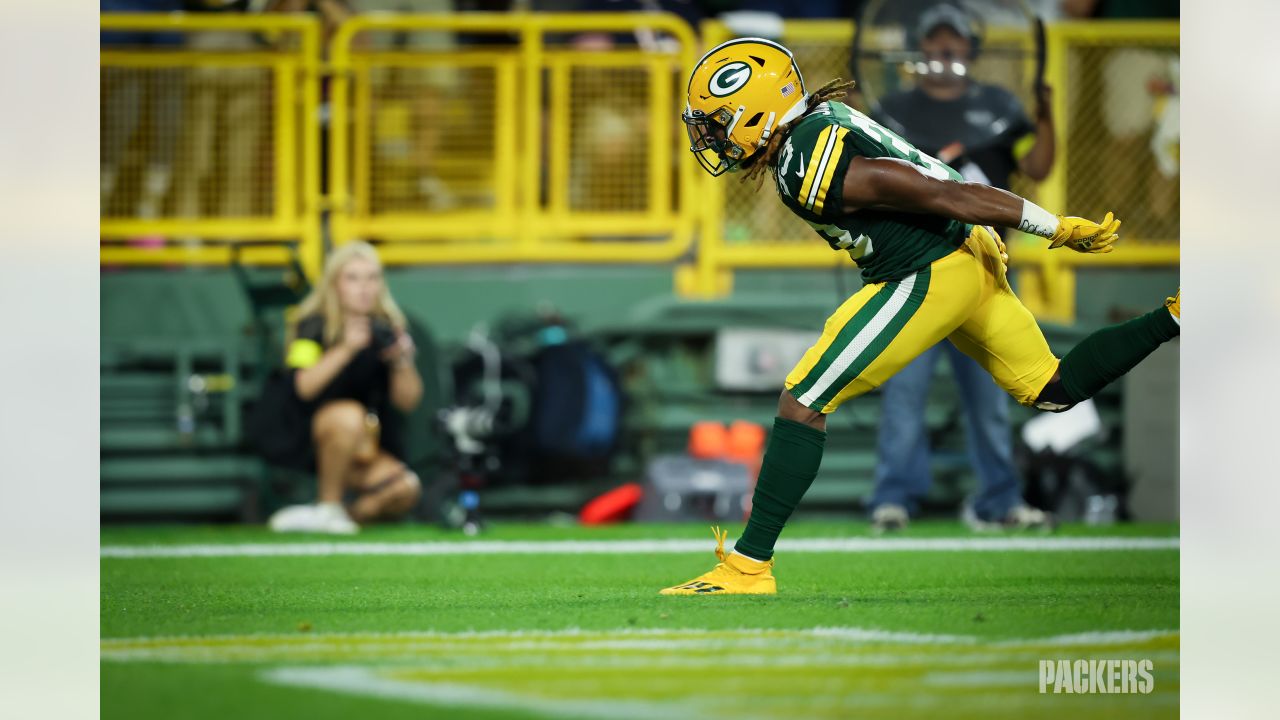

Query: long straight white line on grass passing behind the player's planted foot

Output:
[101, 536, 1179, 559]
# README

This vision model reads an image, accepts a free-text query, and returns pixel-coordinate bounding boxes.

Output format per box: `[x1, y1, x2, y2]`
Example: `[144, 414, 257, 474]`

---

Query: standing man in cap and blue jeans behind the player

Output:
[870, 4, 1055, 532]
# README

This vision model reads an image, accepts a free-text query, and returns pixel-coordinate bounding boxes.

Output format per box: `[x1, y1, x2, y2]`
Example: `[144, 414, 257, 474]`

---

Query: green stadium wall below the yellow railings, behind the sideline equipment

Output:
[101, 265, 1178, 520]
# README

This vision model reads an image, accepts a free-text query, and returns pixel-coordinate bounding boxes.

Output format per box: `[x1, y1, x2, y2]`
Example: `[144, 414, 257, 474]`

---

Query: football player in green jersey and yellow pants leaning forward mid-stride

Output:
[662, 37, 1180, 594]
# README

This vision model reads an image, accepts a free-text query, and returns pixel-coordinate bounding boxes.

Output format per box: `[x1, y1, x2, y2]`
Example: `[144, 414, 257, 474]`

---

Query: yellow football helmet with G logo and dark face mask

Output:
[681, 37, 809, 176]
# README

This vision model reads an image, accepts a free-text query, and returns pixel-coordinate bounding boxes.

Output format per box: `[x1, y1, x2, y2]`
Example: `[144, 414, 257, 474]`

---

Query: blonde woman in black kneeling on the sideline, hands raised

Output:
[270, 242, 422, 533]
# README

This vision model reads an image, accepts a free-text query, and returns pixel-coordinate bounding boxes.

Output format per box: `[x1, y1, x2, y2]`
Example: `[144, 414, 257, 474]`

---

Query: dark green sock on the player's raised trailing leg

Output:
[1059, 302, 1180, 402]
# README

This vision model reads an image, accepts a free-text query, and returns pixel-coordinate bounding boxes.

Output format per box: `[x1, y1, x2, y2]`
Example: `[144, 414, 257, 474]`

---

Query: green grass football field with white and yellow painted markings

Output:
[101, 521, 1179, 720]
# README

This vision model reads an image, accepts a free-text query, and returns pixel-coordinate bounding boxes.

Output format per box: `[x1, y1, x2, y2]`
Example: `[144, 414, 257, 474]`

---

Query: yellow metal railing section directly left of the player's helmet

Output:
[329, 13, 698, 264]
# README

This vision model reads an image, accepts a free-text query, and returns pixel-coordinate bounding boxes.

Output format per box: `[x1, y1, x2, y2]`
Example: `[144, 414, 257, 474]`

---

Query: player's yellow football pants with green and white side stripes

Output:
[786, 227, 1057, 413]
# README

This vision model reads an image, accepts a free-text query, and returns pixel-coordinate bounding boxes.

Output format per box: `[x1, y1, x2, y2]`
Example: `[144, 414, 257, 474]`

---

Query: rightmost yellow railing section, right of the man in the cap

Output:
[1011, 20, 1180, 320]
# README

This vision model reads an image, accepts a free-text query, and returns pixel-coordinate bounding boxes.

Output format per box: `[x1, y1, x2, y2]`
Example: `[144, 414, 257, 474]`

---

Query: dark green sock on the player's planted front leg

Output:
[733, 418, 827, 560]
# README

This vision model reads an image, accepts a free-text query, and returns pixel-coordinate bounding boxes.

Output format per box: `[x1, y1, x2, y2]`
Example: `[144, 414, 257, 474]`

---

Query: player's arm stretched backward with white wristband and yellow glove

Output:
[842, 156, 1120, 252]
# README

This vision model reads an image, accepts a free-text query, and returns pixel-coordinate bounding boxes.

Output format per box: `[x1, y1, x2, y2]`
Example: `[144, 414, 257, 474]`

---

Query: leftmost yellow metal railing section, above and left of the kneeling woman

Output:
[100, 13, 321, 274]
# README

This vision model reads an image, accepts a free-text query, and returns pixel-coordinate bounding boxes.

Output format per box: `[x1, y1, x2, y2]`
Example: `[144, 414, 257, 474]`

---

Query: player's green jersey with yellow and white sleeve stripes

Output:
[773, 101, 972, 283]
